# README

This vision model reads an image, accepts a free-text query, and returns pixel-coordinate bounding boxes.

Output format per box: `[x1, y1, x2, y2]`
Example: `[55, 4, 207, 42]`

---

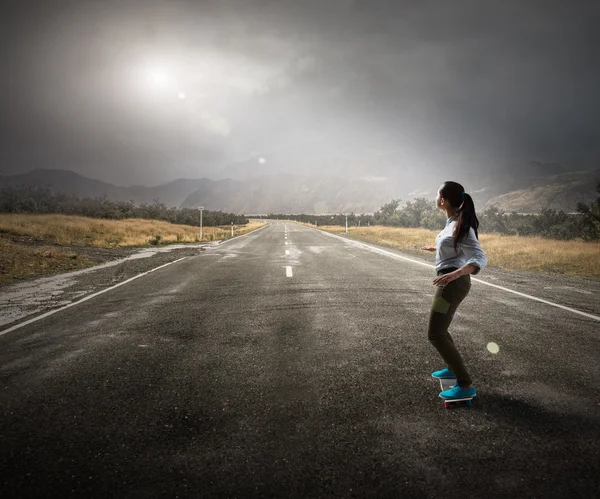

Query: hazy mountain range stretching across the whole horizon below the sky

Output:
[0, 166, 600, 214]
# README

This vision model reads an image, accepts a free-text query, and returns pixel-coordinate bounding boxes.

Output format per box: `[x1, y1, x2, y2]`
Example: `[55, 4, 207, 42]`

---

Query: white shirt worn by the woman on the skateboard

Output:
[435, 215, 487, 275]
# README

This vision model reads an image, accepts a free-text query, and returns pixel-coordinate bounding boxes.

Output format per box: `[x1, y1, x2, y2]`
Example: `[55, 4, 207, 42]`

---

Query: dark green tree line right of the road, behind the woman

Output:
[269, 182, 600, 241]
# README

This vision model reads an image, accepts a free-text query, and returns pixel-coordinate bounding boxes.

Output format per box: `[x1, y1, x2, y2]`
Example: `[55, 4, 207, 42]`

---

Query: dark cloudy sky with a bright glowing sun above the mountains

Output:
[0, 0, 600, 185]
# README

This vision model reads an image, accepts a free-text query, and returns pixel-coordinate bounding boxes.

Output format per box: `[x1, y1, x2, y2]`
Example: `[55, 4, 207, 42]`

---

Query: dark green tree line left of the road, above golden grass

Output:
[0, 186, 248, 227]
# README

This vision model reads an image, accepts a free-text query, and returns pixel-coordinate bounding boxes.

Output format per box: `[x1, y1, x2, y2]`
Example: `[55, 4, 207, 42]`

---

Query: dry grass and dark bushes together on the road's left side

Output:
[0, 186, 262, 286]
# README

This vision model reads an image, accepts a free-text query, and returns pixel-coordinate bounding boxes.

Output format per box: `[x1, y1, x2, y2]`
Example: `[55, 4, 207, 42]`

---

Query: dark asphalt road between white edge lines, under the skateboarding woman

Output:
[0, 222, 600, 498]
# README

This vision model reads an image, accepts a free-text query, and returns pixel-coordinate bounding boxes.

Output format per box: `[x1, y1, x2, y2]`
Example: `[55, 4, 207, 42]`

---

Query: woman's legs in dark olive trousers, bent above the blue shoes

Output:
[427, 275, 472, 387]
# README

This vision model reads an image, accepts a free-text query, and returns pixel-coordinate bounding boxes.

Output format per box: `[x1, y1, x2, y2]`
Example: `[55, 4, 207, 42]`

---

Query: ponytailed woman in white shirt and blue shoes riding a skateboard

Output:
[421, 181, 487, 399]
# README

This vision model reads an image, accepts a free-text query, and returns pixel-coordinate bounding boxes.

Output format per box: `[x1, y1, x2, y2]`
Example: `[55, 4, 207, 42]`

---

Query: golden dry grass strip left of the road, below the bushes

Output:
[0, 214, 264, 248]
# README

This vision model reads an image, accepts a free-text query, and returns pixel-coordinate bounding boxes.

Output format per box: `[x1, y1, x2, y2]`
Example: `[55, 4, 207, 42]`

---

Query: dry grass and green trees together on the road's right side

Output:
[290, 183, 600, 279]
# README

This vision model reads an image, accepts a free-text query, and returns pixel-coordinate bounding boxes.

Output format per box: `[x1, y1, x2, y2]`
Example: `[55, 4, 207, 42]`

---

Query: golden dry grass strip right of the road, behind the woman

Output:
[310, 226, 600, 279]
